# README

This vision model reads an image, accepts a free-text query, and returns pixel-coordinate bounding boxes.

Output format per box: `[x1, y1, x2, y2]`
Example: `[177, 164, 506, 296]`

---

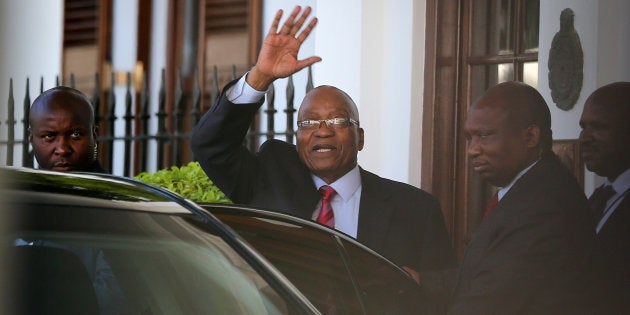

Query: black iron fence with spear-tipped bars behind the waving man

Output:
[0, 67, 313, 176]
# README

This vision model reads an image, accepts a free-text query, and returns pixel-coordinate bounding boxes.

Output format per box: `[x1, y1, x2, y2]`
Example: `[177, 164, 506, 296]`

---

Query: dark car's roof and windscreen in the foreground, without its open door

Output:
[0, 168, 319, 314]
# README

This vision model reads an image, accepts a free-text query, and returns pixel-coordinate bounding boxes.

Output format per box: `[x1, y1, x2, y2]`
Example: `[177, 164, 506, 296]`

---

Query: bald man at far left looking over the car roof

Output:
[28, 86, 105, 173]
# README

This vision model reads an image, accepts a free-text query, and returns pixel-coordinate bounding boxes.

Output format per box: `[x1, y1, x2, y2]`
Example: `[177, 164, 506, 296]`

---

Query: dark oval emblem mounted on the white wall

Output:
[547, 8, 584, 110]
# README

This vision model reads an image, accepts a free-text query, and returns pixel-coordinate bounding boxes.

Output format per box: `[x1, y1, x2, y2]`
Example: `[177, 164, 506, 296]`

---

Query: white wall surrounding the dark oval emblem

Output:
[538, 0, 630, 195]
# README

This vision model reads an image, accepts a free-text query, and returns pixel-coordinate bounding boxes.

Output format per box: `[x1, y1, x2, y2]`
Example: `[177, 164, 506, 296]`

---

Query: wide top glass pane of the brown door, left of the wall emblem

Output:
[471, 0, 514, 56]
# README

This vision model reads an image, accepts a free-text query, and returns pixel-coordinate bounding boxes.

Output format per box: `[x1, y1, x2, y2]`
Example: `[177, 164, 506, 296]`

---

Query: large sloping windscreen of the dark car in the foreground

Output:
[2, 204, 298, 314]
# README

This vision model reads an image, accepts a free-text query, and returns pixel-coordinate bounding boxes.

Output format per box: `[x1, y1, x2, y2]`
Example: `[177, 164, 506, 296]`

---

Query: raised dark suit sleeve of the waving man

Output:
[190, 81, 264, 203]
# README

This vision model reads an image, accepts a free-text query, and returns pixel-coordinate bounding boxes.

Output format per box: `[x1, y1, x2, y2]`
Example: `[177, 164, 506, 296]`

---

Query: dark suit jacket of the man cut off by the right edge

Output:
[593, 180, 630, 314]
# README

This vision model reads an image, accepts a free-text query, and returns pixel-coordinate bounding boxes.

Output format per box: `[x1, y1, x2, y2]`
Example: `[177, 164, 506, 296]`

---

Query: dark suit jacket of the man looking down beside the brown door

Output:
[421, 153, 594, 314]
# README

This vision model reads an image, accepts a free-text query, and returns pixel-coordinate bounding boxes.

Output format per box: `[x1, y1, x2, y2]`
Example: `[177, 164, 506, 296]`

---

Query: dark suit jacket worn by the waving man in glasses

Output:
[191, 80, 454, 270]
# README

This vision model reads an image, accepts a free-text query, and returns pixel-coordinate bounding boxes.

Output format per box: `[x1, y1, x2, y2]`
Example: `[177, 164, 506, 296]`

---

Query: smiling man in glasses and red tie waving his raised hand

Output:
[191, 6, 455, 282]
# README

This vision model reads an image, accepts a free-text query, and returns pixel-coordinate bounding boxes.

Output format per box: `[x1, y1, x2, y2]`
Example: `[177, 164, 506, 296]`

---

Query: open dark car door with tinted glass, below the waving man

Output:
[202, 204, 431, 314]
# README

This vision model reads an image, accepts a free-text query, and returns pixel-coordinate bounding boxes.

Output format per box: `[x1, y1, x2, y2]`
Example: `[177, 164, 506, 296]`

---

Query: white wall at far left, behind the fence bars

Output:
[0, 0, 63, 165]
